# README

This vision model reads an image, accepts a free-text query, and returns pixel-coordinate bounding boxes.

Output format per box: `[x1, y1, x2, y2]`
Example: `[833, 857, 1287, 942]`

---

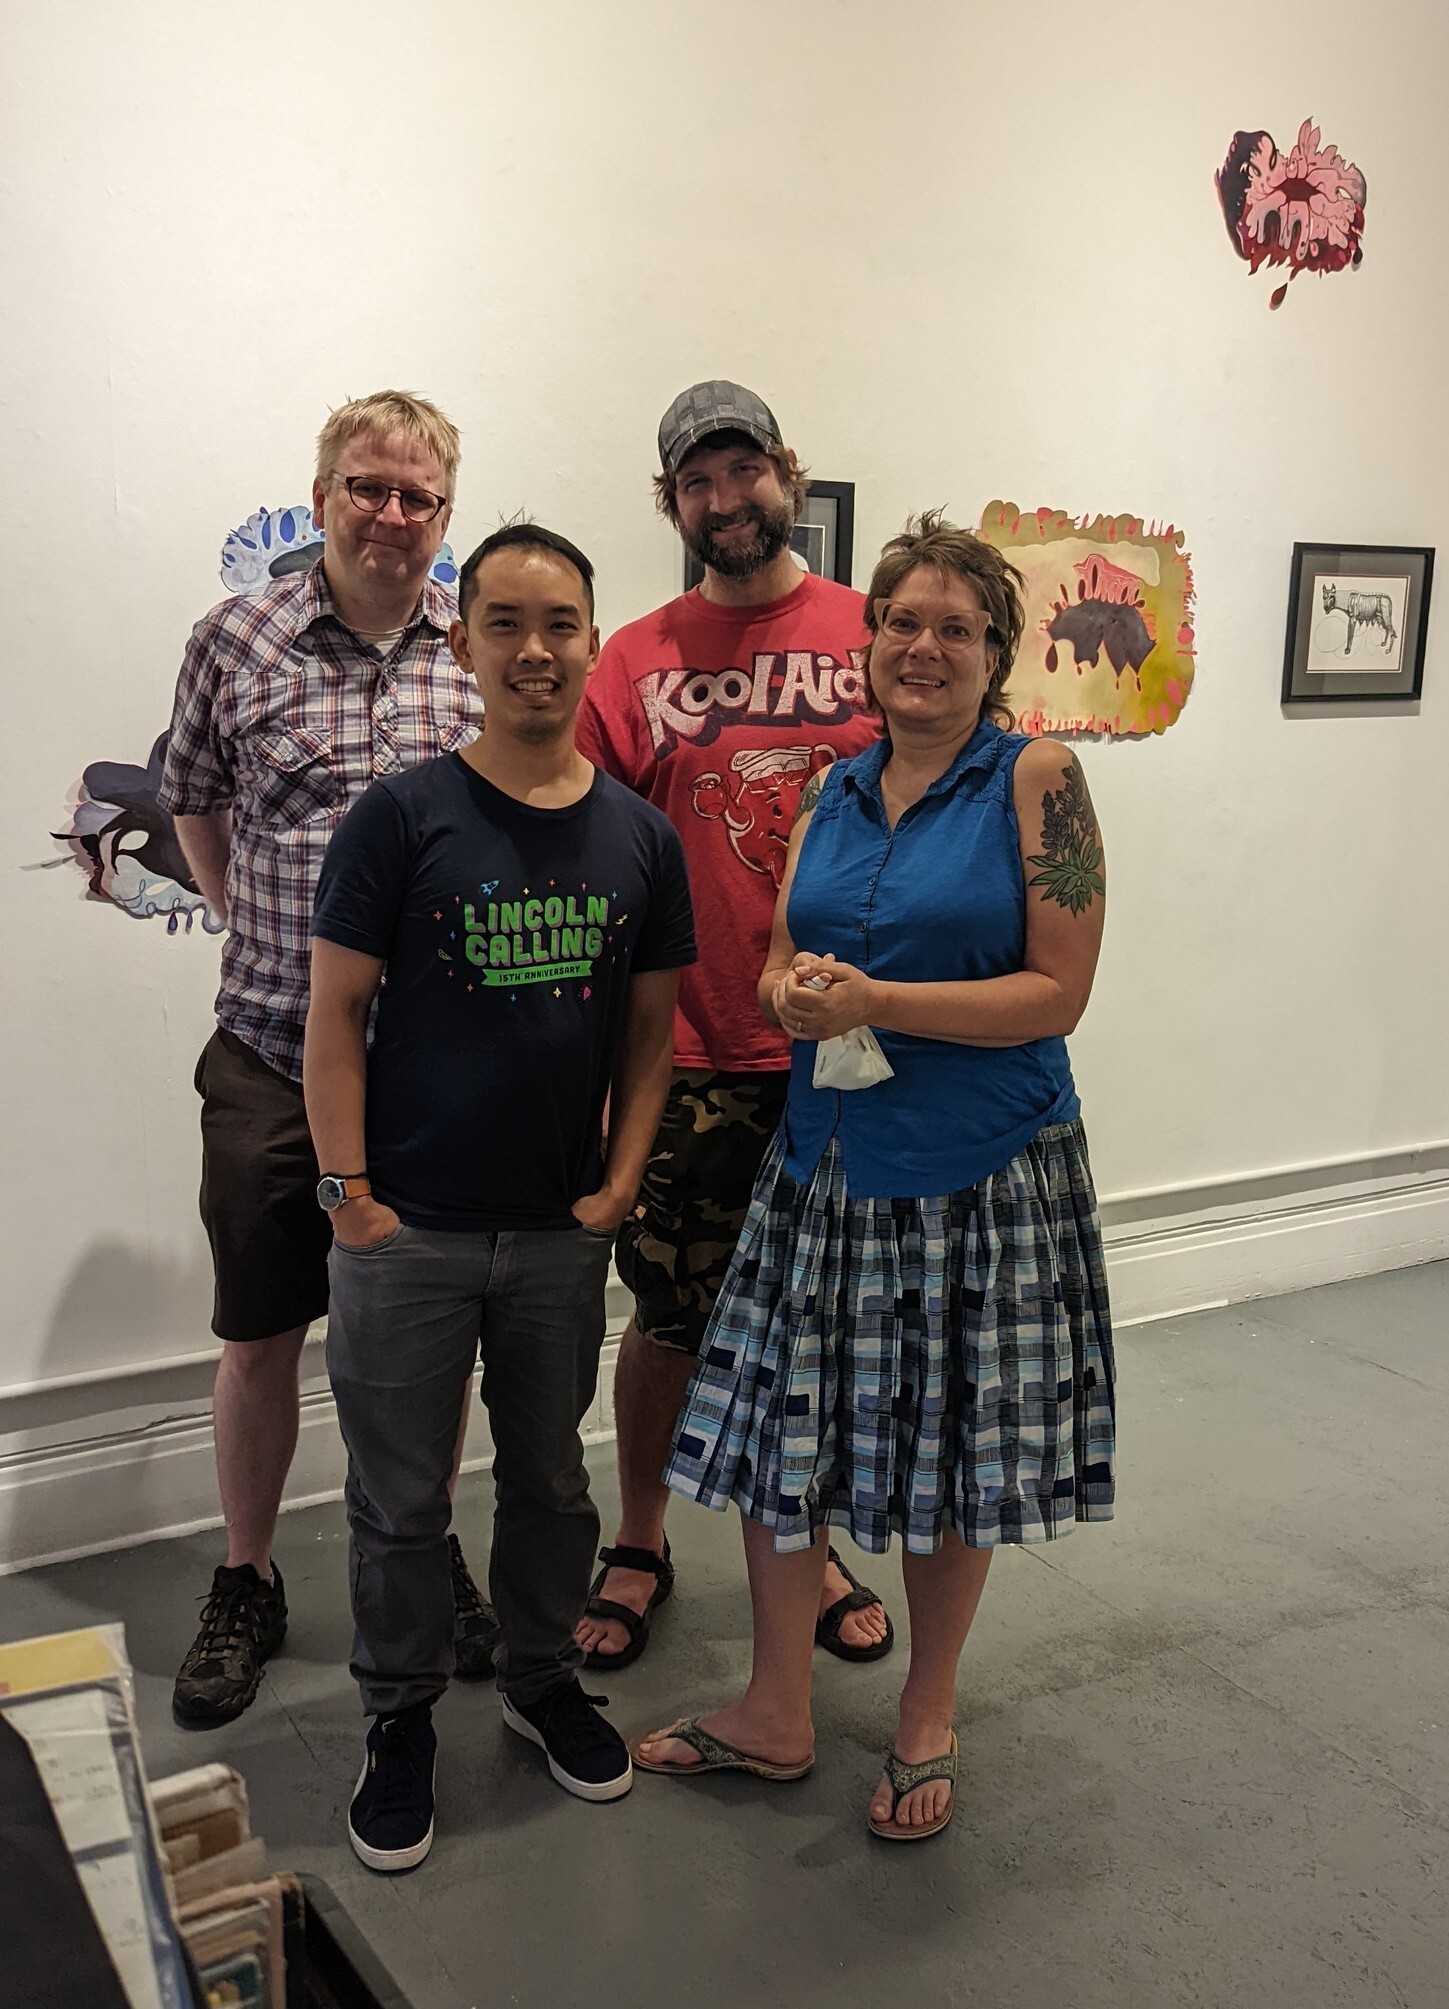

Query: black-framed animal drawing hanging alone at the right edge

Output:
[1282, 544, 1433, 705]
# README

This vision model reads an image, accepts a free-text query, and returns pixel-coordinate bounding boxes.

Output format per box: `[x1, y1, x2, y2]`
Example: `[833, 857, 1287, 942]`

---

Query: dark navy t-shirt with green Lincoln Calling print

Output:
[312, 753, 695, 1232]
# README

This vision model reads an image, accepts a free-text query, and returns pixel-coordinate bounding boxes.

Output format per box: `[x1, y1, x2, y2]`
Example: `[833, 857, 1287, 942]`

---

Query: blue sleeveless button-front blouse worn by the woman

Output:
[784, 721, 1081, 1199]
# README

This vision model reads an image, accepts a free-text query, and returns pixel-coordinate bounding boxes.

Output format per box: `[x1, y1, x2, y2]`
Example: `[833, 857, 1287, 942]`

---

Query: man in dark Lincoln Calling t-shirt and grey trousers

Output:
[303, 524, 695, 1870]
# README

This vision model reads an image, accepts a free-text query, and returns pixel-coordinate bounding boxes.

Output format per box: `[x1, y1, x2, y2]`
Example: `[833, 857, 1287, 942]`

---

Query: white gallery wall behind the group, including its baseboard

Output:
[0, 0, 1449, 1565]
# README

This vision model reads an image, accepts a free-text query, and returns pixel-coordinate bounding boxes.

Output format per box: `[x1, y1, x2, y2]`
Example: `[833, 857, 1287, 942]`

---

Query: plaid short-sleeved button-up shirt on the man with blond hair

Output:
[161, 565, 482, 1081]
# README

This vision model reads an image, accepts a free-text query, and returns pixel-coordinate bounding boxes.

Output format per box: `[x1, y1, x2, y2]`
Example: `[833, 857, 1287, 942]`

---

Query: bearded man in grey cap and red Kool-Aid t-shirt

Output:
[575, 382, 892, 1667]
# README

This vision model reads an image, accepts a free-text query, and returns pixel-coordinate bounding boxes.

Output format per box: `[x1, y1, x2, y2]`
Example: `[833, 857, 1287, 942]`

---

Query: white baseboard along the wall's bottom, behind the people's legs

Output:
[0, 1145, 1449, 1575]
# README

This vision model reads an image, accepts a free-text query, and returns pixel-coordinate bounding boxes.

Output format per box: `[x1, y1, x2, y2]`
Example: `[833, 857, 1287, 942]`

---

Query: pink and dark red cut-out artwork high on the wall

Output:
[1214, 119, 1369, 307]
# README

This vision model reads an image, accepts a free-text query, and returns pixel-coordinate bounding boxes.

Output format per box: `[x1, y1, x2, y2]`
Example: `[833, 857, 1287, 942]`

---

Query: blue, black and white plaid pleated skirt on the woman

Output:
[663, 1123, 1115, 1555]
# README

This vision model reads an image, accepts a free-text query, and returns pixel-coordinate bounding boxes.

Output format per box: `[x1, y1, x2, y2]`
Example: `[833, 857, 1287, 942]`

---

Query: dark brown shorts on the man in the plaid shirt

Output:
[197, 1027, 331, 1340]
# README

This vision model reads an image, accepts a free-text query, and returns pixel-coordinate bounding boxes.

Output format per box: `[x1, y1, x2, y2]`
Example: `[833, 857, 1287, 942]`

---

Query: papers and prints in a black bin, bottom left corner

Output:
[0, 1625, 402, 2009]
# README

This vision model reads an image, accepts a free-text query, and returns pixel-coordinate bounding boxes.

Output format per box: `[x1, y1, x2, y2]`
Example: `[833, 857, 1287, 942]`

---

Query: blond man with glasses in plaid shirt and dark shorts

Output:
[161, 390, 496, 1728]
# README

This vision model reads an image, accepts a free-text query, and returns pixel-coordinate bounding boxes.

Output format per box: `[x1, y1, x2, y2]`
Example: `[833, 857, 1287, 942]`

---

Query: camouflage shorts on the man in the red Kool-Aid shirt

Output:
[615, 1069, 790, 1354]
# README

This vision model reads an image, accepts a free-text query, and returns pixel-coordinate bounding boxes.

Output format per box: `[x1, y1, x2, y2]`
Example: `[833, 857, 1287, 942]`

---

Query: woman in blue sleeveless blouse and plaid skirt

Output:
[635, 514, 1115, 1840]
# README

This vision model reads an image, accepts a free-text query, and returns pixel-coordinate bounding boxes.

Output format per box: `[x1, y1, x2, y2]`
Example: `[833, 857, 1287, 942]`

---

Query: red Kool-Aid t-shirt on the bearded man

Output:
[577, 573, 876, 1075]
